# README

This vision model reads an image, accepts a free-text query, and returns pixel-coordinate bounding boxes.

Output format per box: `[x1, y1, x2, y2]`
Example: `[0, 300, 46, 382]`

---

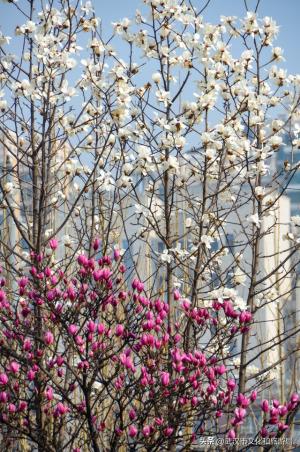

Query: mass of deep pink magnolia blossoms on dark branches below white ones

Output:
[0, 239, 298, 450]
